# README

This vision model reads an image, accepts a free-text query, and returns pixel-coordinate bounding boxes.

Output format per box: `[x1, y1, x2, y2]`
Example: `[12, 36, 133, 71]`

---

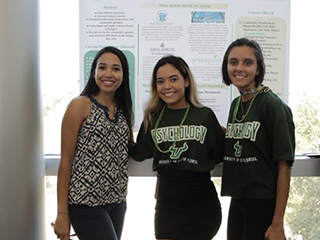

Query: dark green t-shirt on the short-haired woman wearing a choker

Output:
[221, 90, 295, 198]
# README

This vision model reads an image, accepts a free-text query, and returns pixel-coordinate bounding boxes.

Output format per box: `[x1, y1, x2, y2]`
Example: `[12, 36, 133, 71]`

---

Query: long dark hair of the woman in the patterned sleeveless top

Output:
[80, 46, 133, 145]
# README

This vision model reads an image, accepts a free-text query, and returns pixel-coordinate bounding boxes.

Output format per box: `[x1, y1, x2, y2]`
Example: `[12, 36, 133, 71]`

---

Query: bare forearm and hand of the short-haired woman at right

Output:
[265, 160, 291, 240]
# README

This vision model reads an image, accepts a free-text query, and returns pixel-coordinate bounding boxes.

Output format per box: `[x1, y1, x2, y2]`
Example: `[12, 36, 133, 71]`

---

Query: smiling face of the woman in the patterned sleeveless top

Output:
[94, 52, 123, 96]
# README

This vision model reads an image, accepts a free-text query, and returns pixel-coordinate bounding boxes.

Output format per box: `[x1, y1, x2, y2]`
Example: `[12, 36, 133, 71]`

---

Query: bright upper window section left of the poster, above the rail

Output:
[40, 0, 80, 154]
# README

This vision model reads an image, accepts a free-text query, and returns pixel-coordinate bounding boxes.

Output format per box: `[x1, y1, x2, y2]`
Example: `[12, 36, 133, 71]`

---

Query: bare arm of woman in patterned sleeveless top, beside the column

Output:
[55, 97, 91, 240]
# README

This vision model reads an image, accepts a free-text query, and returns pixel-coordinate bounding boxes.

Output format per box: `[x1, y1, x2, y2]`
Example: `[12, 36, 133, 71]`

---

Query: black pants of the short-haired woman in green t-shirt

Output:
[227, 198, 275, 240]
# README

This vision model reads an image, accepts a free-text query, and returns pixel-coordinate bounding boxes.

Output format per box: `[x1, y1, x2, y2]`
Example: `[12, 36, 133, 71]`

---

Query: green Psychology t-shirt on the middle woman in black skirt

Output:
[130, 105, 224, 172]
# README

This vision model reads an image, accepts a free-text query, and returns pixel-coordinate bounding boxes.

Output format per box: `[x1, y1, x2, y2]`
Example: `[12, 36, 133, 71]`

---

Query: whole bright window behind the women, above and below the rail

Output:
[40, 0, 320, 240]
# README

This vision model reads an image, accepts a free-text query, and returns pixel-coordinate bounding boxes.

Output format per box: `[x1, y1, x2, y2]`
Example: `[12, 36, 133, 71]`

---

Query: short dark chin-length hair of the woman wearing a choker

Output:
[221, 38, 266, 87]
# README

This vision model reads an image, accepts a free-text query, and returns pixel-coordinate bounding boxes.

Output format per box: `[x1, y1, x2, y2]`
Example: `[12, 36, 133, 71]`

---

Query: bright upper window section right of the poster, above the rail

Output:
[289, 0, 320, 155]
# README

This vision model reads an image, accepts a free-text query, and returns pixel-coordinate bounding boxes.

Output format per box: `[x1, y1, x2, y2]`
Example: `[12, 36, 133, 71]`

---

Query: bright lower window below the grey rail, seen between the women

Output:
[46, 176, 320, 240]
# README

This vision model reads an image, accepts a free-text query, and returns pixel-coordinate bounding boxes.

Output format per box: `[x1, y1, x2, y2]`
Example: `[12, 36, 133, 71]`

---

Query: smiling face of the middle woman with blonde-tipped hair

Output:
[156, 64, 189, 109]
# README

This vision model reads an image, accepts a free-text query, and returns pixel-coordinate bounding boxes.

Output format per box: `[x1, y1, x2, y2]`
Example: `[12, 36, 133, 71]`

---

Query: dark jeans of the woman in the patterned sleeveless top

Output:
[69, 202, 127, 240]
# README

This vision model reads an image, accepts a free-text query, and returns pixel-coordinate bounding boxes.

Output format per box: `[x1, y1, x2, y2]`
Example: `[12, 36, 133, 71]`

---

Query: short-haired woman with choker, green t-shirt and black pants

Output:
[221, 38, 295, 240]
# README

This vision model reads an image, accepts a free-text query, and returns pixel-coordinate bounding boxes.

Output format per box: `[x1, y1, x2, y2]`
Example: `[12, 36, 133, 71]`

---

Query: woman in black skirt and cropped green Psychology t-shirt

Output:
[131, 56, 224, 240]
